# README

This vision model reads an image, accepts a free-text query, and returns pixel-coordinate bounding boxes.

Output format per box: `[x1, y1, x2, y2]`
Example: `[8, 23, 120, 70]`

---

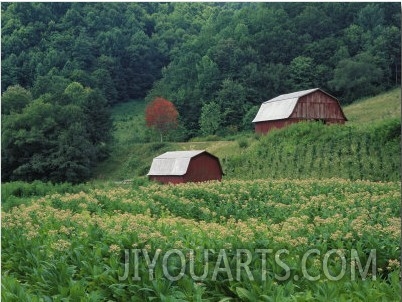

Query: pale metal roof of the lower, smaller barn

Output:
[148, 150, 205, 175]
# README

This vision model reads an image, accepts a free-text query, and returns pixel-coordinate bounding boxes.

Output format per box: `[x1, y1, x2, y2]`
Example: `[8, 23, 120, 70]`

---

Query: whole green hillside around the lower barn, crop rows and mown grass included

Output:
[96, 89, 401, 180]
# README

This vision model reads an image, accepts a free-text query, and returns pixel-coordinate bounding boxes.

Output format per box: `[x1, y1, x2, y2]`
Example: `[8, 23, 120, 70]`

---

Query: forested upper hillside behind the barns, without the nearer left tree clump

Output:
[1, 3, 401, 138]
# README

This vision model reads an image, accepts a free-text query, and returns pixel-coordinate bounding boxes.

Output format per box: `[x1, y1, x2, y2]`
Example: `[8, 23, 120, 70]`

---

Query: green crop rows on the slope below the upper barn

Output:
[222, 119, 401, 181]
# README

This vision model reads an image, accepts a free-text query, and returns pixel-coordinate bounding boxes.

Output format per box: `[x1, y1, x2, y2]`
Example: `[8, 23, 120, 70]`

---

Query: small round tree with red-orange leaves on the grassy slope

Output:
[145, 97, 179, 142]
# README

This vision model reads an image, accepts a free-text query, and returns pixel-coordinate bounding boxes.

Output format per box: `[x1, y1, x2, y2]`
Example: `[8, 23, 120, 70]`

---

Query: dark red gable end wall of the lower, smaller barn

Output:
[184, 153, 222, 182]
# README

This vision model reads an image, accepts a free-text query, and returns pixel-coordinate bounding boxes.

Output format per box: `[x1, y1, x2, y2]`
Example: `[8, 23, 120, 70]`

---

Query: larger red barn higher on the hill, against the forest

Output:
[253, 88, 347, 133]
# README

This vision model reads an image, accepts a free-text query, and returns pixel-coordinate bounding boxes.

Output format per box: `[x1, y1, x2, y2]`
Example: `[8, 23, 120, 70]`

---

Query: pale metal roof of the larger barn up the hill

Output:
[253, 88, 320, 123]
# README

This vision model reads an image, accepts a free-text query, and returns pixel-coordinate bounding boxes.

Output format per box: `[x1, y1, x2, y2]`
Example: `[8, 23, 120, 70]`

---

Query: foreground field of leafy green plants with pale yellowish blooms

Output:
[1, 179, 401, 301]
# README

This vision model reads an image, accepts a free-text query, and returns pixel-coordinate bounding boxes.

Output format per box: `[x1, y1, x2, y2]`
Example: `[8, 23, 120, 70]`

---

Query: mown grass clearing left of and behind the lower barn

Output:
[95, 101, 248, 180]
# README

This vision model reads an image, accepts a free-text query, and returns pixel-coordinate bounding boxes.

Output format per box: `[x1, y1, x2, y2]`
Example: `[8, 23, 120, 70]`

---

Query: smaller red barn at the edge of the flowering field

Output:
[148, 150, 223, 184]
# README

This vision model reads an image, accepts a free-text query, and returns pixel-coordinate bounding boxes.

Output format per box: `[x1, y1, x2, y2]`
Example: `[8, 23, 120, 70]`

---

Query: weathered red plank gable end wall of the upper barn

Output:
[290, 90, 345, 124]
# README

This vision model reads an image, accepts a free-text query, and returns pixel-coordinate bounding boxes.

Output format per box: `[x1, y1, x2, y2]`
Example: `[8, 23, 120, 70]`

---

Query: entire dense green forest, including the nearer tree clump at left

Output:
[1, 2, 401, 182]
